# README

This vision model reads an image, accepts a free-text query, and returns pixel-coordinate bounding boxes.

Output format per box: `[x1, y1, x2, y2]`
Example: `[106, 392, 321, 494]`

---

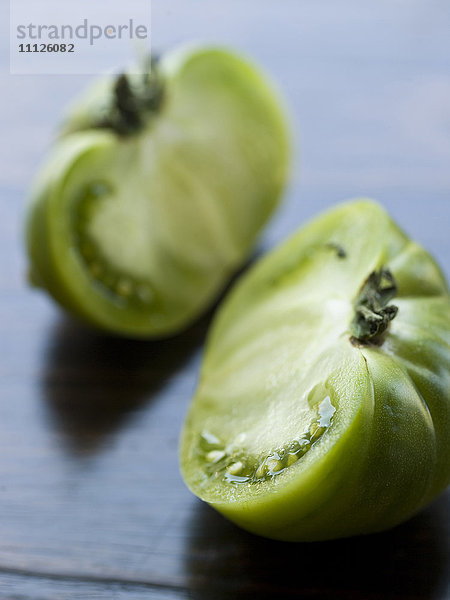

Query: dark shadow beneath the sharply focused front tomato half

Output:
[185, 494, 450, 600]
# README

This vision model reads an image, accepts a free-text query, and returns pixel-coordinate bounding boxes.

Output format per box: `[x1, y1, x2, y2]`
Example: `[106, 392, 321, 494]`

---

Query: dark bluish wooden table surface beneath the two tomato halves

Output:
[0, 0, 450, 600]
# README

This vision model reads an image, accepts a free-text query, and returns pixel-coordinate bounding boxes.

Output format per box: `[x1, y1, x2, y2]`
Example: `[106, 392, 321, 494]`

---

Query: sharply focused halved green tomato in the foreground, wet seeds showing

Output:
[180, 200, 450, 541]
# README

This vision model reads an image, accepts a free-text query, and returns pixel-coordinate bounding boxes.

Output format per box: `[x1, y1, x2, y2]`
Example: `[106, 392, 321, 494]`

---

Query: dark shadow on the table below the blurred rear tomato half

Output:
[42, 314, 211, 457]
